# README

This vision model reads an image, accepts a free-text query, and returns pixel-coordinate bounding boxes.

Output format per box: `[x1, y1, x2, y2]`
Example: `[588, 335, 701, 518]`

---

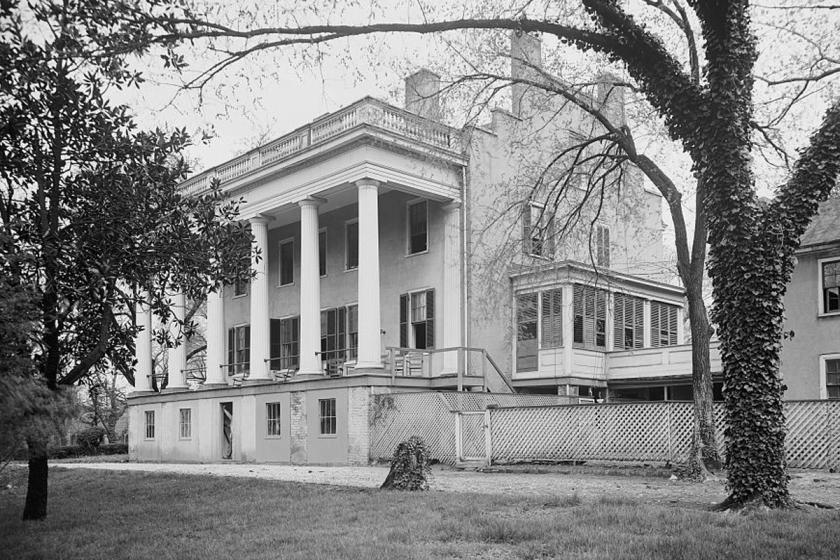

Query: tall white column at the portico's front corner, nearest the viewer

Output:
[356, 179, 382, 369]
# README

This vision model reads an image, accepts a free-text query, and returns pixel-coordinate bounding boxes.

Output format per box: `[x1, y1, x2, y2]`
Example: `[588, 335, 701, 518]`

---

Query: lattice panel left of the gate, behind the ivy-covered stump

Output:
[370, 393, 455, 464]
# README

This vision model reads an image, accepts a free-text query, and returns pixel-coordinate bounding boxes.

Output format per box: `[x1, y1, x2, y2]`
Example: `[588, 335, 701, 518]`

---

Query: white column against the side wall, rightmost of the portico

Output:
[442, 202, 464, 373]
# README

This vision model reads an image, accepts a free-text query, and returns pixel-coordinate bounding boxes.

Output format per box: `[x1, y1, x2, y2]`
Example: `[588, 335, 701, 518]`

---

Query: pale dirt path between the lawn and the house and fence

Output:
[55, 463, 840, 508]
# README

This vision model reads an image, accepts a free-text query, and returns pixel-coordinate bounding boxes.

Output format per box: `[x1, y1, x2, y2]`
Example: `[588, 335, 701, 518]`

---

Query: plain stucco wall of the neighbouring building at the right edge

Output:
[781, 249, 840, 400]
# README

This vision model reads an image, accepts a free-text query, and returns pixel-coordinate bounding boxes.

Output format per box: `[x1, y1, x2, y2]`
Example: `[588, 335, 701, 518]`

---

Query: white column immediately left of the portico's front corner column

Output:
[298, 198, 323, 375]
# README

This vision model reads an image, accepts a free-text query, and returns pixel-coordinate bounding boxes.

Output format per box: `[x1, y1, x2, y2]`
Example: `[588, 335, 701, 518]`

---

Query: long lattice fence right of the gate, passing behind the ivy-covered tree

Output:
[490, 401, 840, 469]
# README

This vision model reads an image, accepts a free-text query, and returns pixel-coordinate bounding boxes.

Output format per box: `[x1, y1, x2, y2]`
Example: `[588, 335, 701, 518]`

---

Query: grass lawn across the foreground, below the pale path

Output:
[0, 468, 840, 560]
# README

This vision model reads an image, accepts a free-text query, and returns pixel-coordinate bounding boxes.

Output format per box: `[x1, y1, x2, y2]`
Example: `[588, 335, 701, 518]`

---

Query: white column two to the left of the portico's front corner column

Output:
[247, 216, 271, 382]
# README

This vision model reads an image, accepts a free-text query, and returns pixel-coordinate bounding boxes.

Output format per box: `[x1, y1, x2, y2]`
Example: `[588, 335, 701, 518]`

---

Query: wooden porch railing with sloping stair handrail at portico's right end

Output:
[386, 346, 516, 393]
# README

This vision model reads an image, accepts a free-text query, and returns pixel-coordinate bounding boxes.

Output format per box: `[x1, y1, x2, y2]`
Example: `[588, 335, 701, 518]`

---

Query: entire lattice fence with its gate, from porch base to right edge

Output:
[370, 392, 840, 469]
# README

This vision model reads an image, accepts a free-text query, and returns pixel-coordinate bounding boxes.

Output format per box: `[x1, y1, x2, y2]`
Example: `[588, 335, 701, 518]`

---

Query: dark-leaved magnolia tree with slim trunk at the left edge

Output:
[0, 1, 250, 519]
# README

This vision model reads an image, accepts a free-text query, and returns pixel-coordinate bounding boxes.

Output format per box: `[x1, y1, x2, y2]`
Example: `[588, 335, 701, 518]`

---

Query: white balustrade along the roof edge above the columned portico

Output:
[180, 97, 463, 196]
